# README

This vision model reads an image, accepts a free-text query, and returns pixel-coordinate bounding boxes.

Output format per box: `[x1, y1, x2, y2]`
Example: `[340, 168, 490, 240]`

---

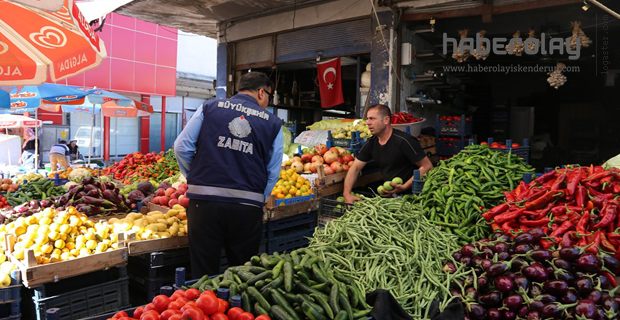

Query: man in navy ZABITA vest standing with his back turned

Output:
[174, 72, 283, 278]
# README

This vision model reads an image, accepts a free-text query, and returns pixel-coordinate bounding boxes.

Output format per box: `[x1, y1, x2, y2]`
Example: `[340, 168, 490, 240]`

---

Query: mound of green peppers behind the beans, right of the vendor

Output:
[413, 145, 534, 244]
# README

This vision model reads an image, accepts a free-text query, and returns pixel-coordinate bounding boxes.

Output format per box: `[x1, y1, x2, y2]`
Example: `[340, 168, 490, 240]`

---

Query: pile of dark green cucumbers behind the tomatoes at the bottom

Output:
[192, 249, 370, 320]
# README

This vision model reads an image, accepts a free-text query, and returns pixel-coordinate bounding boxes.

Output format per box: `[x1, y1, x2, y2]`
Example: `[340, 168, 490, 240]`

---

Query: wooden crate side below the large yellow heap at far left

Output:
[5, 235, 128, 288]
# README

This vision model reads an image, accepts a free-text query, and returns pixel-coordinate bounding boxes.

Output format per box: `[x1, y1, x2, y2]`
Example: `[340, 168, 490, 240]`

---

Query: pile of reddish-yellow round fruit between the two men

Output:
[284, 144, 355, 175]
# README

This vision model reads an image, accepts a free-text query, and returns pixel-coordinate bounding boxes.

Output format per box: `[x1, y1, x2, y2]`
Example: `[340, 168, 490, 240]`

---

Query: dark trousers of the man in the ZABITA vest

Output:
[187, 200, 263, 279]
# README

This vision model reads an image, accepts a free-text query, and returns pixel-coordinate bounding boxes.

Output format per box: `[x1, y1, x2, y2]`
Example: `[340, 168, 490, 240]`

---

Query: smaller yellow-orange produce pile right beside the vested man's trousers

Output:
[108, 204, 187, 240]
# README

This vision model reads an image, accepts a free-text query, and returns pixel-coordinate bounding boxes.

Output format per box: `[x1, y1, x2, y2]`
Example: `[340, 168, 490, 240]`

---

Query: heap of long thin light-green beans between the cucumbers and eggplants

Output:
[309, 197, 459, 319]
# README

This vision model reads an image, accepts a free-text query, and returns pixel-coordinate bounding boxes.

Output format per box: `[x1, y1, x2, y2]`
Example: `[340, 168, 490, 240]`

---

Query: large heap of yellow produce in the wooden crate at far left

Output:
[0, 207, 118, 264]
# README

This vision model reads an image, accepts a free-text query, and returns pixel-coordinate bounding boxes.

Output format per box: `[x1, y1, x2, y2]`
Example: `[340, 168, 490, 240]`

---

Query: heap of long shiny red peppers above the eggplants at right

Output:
[482, 166, 620, 256]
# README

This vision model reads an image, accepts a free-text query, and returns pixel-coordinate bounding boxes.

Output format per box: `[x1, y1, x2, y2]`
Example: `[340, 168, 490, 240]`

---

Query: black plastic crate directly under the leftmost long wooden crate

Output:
[32, 269, 129, 320]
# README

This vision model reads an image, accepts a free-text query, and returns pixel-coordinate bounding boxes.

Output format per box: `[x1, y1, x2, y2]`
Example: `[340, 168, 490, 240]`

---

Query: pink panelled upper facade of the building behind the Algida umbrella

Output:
[61, 13, 177, 96]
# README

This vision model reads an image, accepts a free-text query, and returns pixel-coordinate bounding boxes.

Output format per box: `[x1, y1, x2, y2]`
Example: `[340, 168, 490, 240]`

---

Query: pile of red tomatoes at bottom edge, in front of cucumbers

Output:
[108, 288, 271, 320]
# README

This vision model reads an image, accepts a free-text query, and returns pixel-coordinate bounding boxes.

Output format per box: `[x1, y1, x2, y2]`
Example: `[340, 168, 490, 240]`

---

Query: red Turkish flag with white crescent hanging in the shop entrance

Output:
[316, 58, 344, 108]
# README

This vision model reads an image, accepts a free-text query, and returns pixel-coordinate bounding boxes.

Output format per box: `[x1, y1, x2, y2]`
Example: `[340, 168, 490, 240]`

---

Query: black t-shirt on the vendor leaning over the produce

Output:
[357, 129, 426, 181]
